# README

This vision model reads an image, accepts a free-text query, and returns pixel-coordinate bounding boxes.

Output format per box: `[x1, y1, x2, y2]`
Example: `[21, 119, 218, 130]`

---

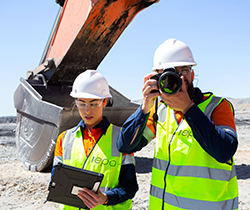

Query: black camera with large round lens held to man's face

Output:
[150, 68, 182, 95]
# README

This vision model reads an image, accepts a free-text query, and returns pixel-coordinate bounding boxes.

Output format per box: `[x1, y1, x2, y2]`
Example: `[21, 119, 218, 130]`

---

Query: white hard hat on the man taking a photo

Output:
[153, 39, 196, 70]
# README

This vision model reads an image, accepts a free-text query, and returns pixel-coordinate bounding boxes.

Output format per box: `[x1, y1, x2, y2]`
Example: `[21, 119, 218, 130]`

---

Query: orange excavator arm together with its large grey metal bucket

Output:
[14, 0, 157, 171]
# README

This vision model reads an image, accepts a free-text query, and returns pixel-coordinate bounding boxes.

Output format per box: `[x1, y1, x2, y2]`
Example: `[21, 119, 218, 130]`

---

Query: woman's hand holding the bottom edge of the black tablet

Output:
[77, 188, 108, 209]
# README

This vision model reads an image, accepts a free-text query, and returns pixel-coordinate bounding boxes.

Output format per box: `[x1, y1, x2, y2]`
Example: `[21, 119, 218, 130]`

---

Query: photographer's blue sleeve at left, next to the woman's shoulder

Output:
[117, 106, 149, 153]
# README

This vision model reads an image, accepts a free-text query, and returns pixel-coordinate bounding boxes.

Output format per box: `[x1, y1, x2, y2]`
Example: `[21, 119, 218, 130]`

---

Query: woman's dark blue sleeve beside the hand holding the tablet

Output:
[104, 164, 138, 206]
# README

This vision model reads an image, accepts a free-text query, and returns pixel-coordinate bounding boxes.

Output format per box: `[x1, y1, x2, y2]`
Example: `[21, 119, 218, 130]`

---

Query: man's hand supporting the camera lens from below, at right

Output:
[160, 76, 194, 114]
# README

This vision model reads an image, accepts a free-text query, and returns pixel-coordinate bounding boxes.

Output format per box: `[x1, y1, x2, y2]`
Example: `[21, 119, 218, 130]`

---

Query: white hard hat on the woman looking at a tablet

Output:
[70, 70, 112, 99]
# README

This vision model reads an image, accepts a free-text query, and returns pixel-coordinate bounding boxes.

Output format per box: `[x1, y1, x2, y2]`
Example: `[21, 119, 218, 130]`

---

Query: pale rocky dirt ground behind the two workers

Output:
[0, 99, 250, 210]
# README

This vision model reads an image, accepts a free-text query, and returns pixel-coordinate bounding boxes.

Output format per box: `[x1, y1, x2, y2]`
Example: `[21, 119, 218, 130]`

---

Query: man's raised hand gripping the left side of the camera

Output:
[142, 72, 160, 114]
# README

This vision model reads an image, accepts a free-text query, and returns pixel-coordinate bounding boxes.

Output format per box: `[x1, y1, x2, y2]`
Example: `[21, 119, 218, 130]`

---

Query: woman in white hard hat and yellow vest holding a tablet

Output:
[52, 70, 138, 210]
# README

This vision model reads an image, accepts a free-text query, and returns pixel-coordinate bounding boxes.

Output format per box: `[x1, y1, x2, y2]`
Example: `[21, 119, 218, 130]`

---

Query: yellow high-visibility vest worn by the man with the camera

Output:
[149, 93, 238, 210]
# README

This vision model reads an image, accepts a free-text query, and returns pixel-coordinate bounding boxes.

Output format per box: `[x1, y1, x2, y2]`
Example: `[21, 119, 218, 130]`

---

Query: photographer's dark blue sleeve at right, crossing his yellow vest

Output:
[184, 105, 238, 163]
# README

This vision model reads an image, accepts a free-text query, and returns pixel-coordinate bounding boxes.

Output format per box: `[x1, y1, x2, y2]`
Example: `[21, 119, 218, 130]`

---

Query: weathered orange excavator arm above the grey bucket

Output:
[27, 0, 155, 85]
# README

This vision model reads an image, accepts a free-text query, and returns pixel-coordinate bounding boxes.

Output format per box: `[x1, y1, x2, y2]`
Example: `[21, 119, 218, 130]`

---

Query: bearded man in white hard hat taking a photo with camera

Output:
[118, 39, 238, 210]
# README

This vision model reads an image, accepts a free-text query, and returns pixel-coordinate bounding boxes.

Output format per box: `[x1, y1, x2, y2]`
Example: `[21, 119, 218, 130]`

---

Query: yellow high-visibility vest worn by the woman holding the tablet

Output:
[59, 124, 132, 210]
